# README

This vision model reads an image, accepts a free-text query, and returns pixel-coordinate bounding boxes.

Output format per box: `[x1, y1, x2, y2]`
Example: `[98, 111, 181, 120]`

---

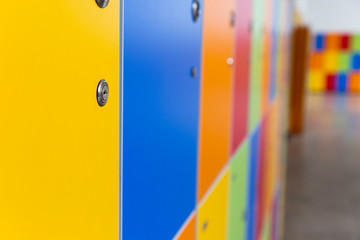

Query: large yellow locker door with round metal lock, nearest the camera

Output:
[0, 0, 120, 240]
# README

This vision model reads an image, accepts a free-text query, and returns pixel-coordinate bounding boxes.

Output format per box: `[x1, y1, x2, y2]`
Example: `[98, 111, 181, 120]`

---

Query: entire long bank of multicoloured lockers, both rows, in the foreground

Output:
[0, 0, 286, 240]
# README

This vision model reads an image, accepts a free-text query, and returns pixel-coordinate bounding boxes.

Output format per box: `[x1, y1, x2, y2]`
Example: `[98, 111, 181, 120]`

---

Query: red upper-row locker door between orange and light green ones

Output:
[231, 0, 252, 154]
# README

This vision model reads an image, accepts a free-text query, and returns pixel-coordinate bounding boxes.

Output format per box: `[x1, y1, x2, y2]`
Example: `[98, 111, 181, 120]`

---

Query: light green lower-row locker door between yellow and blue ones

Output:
[229, 141, 249, 240]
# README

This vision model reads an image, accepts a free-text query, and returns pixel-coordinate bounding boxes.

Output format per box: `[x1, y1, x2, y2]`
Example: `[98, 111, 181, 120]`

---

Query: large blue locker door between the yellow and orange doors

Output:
[122, 0, 202, 240]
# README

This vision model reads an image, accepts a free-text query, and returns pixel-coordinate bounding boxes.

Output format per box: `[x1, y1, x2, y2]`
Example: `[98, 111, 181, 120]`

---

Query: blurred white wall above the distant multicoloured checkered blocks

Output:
[295, 0, 360, 33]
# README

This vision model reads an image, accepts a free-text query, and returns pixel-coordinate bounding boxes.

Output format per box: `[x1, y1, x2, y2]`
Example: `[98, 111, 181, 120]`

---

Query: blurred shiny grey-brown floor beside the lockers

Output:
[284, 95, 360, 240]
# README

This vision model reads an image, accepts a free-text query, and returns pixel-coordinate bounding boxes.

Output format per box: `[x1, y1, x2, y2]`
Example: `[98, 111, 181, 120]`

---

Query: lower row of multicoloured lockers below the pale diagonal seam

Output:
[176, 114, 282, 240]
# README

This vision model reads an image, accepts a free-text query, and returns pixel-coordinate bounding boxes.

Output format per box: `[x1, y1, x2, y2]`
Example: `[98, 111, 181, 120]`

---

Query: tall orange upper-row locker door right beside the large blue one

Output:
[198, 0, 235, 200]
